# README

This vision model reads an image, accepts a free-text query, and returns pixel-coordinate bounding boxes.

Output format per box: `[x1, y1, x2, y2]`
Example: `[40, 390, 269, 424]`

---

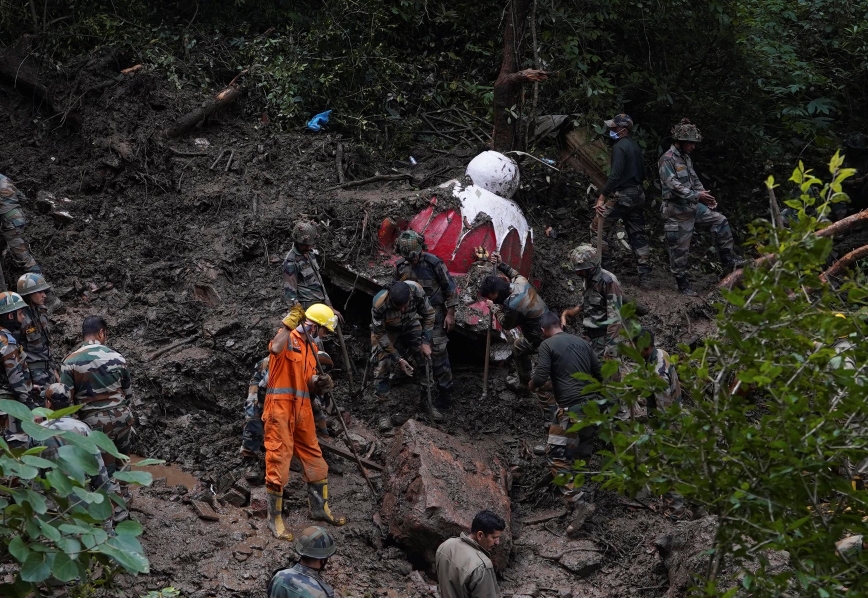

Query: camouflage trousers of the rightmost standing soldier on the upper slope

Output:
[662, 201, 733, 277]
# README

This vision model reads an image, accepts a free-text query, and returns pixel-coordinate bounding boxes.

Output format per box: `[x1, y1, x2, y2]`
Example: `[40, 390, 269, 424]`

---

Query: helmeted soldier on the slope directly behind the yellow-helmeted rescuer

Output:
[283, 220, 343, 329]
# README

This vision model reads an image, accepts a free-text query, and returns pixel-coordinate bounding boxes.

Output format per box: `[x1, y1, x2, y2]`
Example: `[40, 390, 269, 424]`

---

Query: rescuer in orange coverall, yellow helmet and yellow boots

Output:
[262, 303, 347, 540]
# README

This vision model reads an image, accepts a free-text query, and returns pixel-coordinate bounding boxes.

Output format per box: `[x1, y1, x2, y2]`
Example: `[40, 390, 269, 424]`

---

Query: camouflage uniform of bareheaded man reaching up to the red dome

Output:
[492, 262, 549, 386]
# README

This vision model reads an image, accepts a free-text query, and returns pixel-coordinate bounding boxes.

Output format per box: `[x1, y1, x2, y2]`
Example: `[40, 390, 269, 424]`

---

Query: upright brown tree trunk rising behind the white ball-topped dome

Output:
[491, 0, 531, 152]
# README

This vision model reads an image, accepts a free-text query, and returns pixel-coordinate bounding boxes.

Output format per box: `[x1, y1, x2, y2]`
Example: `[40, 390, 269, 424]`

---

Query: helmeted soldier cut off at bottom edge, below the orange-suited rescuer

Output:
[268, 526, 337, 598]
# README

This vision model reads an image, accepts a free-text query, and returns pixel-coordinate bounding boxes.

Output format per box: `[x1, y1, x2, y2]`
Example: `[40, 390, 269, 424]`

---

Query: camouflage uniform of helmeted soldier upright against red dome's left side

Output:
[395, 253, 458, 393]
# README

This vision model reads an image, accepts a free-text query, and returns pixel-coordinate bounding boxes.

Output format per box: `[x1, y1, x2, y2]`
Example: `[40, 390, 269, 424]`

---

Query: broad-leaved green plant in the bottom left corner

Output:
[0, 400, 158, 597]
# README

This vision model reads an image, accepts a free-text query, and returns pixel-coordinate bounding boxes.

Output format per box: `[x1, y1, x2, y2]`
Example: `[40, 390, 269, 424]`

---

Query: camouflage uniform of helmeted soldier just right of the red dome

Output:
[582, 266, 624, 359]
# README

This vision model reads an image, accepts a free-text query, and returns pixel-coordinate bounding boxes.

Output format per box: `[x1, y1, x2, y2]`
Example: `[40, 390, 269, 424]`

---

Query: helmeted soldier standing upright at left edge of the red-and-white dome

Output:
[395, 230, 458, 409]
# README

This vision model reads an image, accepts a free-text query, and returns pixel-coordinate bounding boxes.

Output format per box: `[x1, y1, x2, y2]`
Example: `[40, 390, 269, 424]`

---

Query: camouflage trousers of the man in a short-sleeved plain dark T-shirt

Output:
[546, 402, 597, 497]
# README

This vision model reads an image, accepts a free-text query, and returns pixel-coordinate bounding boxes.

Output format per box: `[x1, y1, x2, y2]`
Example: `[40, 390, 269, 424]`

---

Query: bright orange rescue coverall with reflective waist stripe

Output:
[262, 329, 328, 493]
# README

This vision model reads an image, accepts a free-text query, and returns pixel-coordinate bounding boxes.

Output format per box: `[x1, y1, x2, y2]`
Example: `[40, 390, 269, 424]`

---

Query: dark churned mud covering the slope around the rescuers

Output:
[0, 58, 716, 597]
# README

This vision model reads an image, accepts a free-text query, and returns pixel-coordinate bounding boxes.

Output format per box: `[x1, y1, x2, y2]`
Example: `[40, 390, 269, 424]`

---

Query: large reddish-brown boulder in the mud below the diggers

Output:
[380, 419, 512, 570]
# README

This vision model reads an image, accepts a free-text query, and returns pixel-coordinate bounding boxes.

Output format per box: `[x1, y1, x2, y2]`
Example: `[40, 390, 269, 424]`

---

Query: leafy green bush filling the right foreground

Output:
[568, 154, 868, 597]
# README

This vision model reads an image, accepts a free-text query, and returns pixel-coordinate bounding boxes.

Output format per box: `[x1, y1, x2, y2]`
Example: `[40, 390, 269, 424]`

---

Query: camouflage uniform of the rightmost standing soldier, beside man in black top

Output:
[657, 145, 733, 277]
